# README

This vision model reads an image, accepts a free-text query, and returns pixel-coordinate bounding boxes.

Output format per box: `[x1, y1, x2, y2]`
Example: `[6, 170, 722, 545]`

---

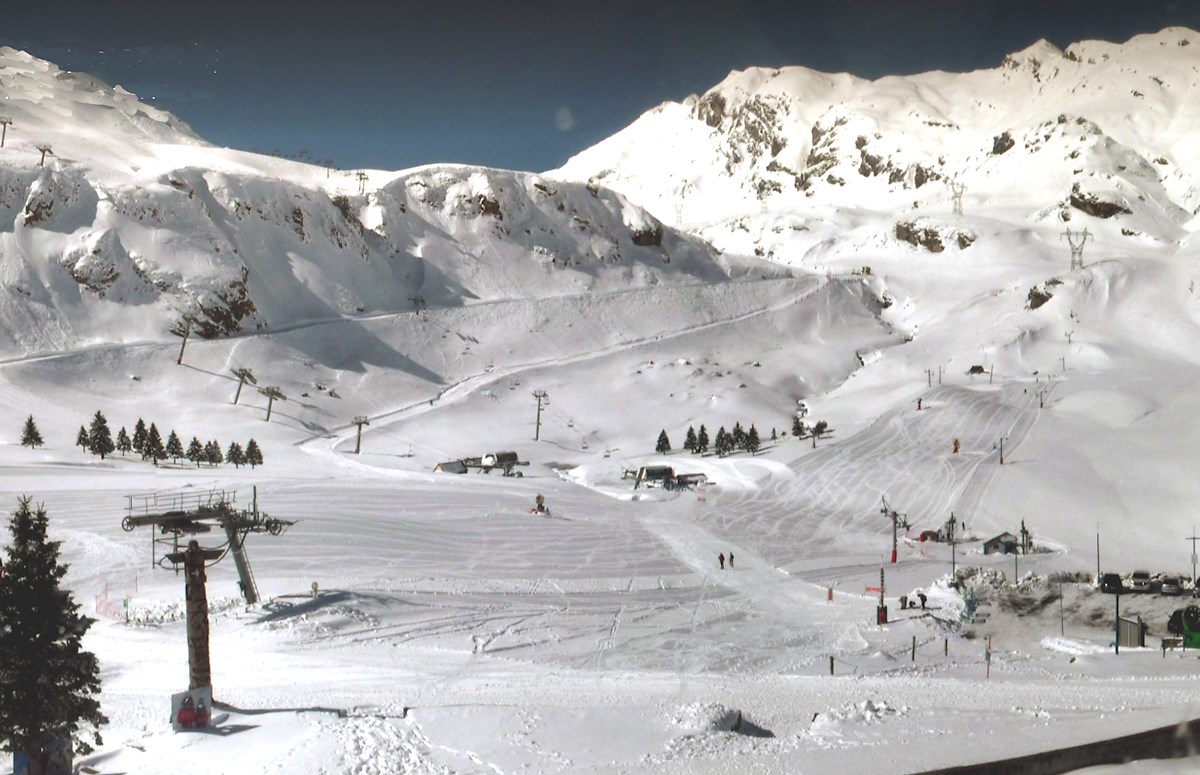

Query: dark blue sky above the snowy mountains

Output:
[0, 0, 1200, 170]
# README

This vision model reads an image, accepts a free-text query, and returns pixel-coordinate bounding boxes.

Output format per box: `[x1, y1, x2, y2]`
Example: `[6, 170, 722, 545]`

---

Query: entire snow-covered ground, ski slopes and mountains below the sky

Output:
[11, 30, 1200, 774]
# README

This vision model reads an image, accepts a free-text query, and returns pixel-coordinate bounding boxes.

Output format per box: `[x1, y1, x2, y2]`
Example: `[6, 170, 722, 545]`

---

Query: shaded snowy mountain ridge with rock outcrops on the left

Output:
[0, 49, 758, 353]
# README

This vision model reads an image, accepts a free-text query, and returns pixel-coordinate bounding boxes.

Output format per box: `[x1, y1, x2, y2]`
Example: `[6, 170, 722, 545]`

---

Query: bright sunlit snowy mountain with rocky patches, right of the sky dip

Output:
[552, 28, 1200, 263]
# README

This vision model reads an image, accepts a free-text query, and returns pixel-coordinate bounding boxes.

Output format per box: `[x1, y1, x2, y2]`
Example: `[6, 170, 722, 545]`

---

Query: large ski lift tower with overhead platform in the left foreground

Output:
[121, 488, 295, 690]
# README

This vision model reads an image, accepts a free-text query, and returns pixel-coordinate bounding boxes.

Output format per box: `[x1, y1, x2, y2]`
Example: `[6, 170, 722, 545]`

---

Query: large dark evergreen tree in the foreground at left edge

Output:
[0, 498, 108, 773]
